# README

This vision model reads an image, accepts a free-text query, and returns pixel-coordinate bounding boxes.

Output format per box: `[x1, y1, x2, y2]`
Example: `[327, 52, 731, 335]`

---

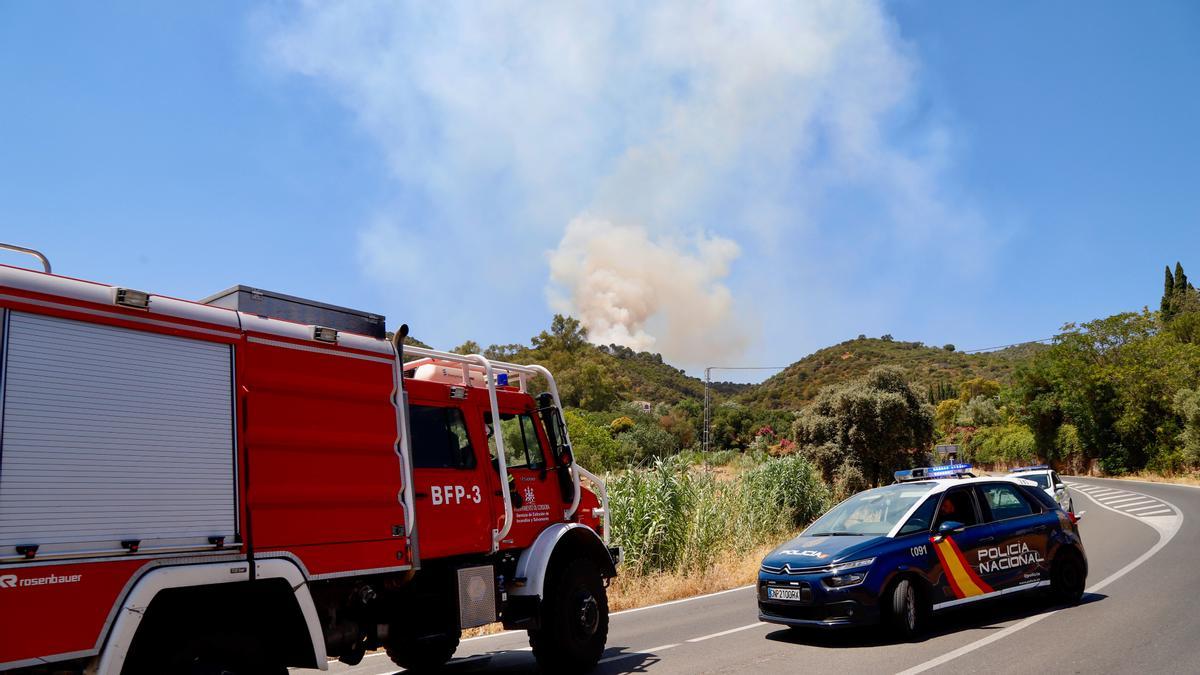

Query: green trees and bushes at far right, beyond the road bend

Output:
[935, 263, 1200, 476]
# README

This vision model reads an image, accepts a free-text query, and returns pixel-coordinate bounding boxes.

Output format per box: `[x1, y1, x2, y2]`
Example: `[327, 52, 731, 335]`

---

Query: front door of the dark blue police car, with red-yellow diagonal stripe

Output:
[930, 485, 994, 608]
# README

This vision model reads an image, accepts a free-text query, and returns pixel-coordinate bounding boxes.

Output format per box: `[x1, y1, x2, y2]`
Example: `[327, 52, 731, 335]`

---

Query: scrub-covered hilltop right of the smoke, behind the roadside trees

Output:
[736, 336, 1046, 410]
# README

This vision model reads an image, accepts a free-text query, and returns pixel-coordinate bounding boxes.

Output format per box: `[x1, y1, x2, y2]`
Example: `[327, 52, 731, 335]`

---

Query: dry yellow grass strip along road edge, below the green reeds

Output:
[462, 538, 784, 639]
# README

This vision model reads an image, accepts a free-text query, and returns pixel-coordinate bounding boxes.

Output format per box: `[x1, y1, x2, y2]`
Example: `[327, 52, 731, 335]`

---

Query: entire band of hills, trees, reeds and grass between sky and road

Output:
[456, 257, 1200, 608]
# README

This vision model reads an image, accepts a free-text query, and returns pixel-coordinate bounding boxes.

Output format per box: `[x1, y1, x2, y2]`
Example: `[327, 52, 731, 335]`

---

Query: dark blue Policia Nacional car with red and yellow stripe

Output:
[758, 465, 1087, 638]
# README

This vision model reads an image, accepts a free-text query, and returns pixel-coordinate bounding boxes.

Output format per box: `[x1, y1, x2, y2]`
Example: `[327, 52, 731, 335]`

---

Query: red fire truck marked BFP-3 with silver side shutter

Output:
[0, 246, 620, 675]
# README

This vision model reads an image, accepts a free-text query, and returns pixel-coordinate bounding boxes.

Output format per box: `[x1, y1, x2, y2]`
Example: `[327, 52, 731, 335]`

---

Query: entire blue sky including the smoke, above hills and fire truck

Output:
[0, 0, 1200, 372]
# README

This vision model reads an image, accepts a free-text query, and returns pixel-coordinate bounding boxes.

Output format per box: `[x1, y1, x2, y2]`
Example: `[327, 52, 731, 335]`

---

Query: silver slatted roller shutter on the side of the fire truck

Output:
[0, 312, 236, 558]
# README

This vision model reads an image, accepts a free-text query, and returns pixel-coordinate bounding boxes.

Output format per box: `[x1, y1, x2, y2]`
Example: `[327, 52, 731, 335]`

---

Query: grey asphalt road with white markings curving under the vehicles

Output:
[300, 478, 1200, 675]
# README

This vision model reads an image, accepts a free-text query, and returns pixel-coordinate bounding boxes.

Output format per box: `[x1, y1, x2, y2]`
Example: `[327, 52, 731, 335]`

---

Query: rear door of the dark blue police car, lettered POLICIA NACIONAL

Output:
[976, 483, 1057, 591]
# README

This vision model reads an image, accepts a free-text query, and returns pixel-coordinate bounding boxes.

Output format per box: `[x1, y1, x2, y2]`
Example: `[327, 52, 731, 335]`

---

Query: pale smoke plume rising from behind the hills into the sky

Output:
[256, 0, 971, 366]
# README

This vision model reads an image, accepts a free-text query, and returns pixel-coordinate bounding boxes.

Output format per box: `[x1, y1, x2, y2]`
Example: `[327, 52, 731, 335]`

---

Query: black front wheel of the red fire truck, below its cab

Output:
[529, 558, 608, 673]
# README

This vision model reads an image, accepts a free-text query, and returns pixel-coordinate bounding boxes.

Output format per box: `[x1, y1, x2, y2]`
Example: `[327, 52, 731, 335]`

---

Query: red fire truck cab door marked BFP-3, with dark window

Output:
[408, 399, 493, 558]
